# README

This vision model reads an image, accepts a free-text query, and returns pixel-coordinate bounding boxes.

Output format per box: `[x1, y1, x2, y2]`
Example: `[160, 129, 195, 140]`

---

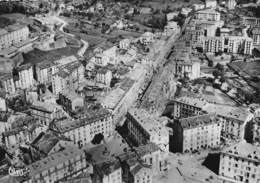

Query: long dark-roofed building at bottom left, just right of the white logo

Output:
[24, 147, 92, 183]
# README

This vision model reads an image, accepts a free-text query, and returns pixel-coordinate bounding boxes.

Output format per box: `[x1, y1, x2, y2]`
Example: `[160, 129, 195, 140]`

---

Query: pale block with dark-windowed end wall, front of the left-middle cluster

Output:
[52, 62, 85, 95]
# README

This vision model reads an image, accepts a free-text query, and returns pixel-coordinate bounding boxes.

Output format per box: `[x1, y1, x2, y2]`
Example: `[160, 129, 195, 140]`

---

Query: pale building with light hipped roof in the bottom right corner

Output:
[219, 141, 260, 183]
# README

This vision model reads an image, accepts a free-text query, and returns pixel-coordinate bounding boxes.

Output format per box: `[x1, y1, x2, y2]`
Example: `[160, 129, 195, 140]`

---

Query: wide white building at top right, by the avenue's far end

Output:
[195, 9, 220, 21]
